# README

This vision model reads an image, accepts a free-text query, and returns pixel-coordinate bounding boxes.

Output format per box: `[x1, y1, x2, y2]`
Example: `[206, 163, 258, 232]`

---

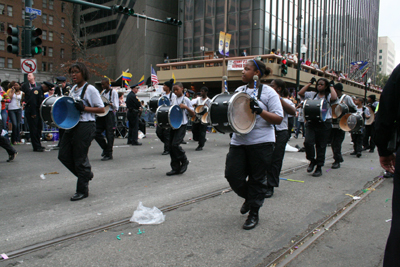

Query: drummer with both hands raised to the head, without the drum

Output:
[299, 77, 337, 177]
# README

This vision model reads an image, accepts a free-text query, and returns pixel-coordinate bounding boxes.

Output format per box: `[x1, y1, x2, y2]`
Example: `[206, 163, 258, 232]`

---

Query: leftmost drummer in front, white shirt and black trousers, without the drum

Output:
[58, 62, 104, 201]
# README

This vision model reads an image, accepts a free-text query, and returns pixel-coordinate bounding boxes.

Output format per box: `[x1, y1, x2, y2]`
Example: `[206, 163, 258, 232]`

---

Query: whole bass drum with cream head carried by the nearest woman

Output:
[205, 92, 256, 134]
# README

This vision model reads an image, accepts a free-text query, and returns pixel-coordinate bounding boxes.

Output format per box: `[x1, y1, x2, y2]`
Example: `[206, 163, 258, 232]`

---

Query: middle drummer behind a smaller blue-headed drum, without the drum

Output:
[167, 82, 195, 176]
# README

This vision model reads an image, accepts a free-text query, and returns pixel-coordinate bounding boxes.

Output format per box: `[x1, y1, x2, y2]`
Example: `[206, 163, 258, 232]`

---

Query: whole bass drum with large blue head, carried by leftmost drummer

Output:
[40, 96, 81, 130]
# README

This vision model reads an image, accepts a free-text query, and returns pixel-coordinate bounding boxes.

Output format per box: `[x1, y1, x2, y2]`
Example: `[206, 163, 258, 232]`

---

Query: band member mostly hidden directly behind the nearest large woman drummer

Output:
[265, 79, 296, 198]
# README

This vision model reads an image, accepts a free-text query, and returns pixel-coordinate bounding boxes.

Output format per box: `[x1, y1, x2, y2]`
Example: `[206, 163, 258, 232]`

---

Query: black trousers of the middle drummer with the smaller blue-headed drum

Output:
[169, 124, 187, 172]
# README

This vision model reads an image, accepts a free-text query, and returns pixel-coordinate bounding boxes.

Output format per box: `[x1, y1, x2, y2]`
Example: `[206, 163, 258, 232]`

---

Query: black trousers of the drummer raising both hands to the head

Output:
[304, 121, 332, 166]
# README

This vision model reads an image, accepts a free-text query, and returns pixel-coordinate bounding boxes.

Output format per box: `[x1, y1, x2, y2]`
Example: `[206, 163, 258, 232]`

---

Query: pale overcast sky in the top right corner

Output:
[378, 0, 400, 66]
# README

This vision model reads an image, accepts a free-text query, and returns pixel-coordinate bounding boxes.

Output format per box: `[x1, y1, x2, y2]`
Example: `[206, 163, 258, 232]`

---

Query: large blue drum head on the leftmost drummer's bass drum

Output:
[52, 96, 81, 129]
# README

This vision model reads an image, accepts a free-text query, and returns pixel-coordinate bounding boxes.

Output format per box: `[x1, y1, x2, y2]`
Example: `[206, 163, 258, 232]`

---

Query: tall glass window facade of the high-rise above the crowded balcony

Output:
[179, 0, 379, 72]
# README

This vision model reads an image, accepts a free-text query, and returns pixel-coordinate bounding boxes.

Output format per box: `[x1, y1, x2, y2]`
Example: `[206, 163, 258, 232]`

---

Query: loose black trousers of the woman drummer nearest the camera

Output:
[225, 143, 274, 207]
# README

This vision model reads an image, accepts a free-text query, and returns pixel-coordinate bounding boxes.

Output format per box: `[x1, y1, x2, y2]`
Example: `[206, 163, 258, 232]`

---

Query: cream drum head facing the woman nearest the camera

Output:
[228, 92, 256, 134]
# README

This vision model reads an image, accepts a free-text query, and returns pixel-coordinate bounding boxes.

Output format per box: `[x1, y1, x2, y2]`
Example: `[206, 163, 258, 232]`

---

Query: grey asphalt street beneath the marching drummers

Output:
[0, 129, 391, 266]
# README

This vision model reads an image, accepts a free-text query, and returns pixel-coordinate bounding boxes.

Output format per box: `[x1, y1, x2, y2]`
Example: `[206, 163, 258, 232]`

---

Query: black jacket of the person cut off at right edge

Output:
[374, 64, 400, 156]
